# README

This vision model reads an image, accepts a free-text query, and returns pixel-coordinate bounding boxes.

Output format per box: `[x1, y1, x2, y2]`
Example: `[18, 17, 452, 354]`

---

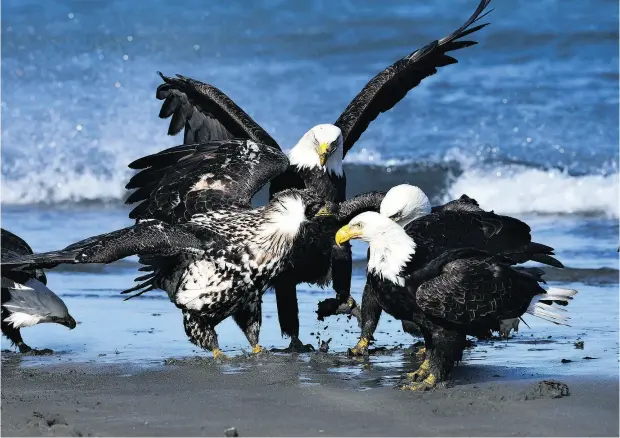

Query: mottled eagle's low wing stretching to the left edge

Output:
[2, 220, 218, 273]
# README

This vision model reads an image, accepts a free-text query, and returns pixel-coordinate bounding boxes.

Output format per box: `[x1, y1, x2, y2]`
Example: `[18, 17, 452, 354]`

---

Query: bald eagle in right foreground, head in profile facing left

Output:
[336, 211, 577, 390]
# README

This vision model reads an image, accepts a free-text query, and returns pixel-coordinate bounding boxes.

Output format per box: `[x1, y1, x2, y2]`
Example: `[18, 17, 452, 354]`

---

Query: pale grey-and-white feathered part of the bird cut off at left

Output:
[2, 277, 76, 329]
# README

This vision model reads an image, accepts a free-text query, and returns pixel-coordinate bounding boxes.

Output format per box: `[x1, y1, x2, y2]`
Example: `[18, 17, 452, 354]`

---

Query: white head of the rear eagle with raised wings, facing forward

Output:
[289, 124, 343, 175]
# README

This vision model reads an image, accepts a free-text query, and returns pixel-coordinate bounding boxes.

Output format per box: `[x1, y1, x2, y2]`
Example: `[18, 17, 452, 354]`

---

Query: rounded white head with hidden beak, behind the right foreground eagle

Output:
[379, 184, 431, 227]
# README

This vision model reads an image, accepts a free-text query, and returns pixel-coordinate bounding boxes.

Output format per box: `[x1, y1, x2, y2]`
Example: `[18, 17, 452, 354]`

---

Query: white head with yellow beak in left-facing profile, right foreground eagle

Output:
[336, 211, 416, 286]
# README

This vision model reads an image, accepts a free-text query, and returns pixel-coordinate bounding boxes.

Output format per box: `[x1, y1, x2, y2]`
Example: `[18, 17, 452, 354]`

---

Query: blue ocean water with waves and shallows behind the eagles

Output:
[1, 0, 619, 373]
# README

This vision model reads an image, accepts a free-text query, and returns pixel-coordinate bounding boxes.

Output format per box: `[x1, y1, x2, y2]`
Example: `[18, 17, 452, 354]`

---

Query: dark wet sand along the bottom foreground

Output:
[1, 351, 619, 436]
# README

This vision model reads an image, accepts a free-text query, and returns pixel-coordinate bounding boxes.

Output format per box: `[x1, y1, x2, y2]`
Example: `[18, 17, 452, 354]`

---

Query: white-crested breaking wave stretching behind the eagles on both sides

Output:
[2, 150, 619, 218]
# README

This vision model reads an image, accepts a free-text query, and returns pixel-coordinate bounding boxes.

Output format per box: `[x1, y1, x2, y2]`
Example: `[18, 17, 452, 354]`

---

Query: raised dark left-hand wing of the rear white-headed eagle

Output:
[156, 72, 279, 149]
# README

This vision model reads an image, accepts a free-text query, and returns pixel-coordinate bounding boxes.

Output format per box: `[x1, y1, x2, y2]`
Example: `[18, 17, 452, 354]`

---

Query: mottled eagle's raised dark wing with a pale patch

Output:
[125, 140, 289, 223]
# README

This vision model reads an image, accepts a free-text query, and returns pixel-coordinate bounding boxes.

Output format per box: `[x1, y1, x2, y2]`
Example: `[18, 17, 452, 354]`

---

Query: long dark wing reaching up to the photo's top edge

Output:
[335, 0, 491, 154]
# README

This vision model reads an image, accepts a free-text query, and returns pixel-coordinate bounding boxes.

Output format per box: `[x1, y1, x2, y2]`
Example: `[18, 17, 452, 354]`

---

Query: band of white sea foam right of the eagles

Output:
[445, 166, 619, 218]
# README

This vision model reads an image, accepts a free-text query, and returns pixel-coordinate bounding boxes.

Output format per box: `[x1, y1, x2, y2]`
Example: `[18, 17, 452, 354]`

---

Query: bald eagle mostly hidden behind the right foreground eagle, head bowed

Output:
[349, 184, 563, 356]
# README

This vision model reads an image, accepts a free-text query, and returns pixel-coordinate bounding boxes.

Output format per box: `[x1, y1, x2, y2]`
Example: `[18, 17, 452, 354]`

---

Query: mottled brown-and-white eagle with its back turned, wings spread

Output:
[2, 140, 333, 358]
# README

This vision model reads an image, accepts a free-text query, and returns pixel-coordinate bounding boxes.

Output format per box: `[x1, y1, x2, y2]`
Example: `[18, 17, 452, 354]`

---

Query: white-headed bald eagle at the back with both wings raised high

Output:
[136, 0, 490, 351]
